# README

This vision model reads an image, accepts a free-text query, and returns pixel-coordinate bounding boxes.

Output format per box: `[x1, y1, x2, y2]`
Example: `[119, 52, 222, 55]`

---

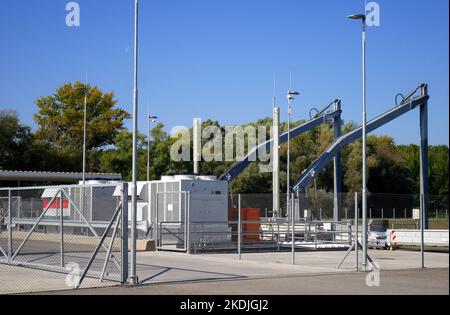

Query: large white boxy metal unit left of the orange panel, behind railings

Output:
[149, 175, 231, 246]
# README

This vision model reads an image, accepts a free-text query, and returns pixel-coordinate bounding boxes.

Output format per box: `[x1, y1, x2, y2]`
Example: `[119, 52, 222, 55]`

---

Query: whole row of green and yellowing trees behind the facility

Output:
[0, 82, 449, 204]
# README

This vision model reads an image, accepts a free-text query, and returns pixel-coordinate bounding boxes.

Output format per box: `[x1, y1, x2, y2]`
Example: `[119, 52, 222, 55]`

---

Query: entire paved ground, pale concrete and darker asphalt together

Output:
[0, 250, 449, 295]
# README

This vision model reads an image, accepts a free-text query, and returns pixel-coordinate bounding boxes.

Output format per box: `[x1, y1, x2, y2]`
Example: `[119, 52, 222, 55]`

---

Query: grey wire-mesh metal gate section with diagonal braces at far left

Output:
[0, 183, 128, 288]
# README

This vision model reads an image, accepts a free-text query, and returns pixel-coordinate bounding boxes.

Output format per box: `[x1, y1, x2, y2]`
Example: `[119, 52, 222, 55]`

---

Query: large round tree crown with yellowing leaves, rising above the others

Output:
[34, 82, 130, 160]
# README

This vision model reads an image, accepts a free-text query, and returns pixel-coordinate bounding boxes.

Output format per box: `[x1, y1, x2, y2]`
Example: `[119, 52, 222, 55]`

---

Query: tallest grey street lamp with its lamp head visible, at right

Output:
[348, 14, 368, 271]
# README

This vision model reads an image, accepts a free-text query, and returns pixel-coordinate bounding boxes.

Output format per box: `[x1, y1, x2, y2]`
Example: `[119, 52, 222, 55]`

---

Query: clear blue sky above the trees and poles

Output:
[0, 0, 449, 144]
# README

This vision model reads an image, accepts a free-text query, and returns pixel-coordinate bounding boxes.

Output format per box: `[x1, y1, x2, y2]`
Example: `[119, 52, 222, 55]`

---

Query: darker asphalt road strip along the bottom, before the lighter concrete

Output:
[40, 268, 449, 295]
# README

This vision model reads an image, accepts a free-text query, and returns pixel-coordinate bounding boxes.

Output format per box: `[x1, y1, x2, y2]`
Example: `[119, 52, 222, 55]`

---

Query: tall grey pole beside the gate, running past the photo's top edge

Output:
[128, 0, 139, 285]
